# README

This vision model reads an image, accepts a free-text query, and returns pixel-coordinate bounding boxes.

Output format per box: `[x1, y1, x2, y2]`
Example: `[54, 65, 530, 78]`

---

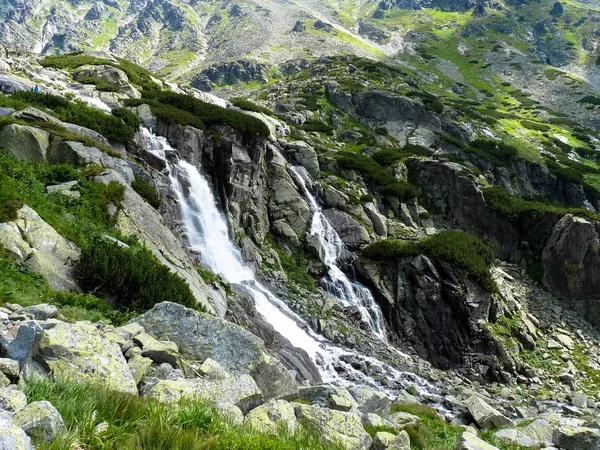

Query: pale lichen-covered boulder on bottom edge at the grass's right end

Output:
[294, 404, 372, 450]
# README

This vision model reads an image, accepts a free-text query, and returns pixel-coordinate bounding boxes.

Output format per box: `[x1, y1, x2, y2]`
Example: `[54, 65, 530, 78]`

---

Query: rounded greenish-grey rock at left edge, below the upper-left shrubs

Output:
[0, 124, 50, 162]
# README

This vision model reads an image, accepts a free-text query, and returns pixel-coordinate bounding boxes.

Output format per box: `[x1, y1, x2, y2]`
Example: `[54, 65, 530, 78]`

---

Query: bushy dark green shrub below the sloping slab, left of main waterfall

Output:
[76, 238, 198, 310]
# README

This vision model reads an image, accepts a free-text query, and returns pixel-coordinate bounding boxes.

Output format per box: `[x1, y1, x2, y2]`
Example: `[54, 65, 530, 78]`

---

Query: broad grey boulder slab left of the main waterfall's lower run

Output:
[132, 302, 298, 400]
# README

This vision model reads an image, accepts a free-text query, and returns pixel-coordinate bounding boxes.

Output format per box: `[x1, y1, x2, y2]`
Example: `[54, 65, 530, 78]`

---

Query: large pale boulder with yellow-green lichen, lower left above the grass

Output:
[38, 319, 137, 394]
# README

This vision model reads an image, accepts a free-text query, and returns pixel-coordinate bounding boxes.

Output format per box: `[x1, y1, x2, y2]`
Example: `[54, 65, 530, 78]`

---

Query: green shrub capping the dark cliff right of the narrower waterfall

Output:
[361, 230, 497, 292]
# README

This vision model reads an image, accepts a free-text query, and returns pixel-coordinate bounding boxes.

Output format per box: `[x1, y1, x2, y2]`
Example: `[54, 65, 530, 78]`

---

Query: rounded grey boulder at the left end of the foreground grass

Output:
[13, 401, 65, 442]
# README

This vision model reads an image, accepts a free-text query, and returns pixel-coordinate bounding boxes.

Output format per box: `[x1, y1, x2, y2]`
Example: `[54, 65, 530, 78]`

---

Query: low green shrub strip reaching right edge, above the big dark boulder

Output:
[483, 186, 600, 221]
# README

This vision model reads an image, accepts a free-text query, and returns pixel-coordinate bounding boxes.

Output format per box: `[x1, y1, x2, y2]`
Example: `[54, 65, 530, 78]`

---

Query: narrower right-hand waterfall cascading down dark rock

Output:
[291, 166, 387, 342]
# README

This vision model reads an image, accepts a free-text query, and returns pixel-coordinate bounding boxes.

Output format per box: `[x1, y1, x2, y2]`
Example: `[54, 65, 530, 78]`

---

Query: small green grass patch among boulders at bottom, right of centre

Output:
[391, 403, 464, 450]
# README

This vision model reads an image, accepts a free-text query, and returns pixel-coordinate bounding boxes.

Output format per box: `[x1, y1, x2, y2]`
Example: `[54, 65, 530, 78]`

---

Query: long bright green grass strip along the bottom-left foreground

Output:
[23, 379, 342, 450]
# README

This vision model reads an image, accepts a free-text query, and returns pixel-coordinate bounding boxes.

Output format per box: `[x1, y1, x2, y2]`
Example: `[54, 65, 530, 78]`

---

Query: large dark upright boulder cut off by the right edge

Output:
[542, 214, 600, 325]
